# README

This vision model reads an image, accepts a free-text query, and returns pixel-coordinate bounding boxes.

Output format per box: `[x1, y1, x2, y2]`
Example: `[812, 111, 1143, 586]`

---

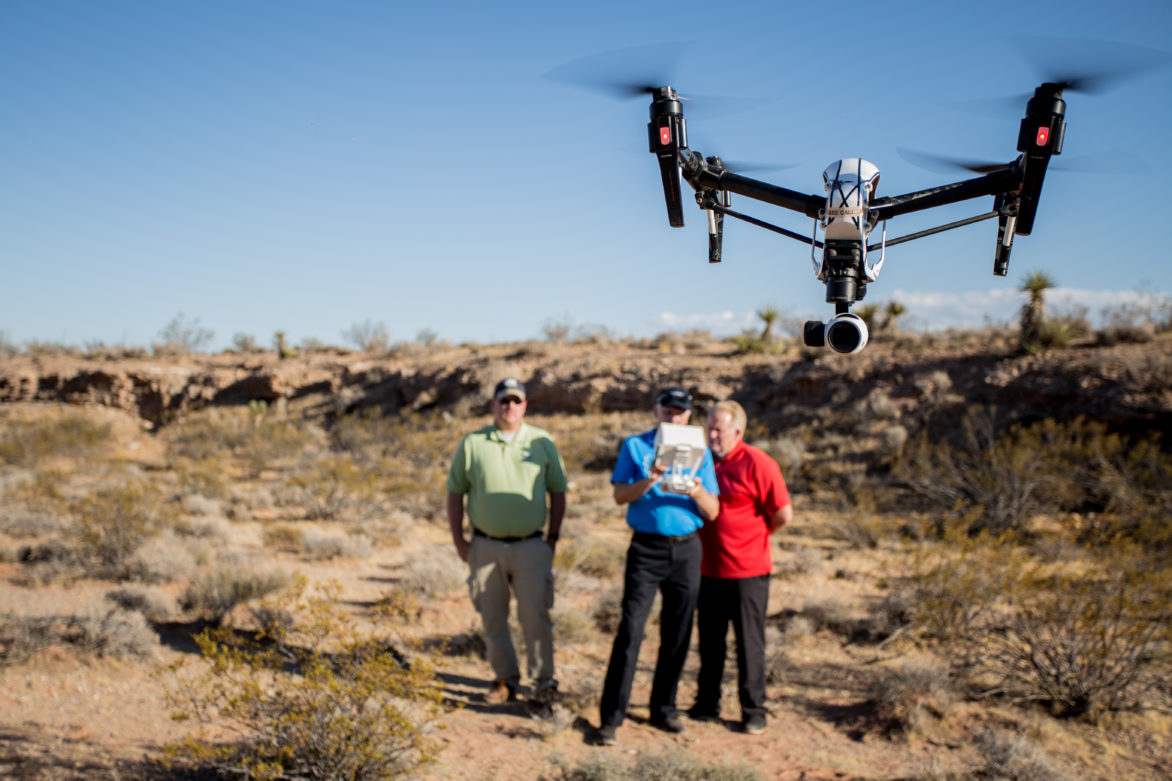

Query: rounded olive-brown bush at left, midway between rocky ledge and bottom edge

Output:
[71, 480, 169, 579]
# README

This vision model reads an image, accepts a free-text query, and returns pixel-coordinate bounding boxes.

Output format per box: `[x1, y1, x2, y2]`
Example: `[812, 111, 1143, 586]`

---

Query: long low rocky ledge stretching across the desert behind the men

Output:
[0, 330, 1172, 434]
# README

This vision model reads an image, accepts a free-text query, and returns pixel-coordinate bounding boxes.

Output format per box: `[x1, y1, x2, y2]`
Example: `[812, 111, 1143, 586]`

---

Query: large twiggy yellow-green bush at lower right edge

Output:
[912, 534, 1172, 719]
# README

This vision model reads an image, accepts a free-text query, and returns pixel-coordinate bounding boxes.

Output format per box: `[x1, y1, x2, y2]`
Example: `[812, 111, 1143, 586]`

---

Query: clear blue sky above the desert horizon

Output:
[0, 0, 1172, 347]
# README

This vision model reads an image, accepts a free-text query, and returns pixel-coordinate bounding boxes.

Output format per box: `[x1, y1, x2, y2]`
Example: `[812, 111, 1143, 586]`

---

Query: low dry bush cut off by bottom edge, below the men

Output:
[540, 748, 763, 781]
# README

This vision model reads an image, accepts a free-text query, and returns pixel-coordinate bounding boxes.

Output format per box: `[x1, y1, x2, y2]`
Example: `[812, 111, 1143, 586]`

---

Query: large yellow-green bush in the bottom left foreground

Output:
[165, 574, 442, 781]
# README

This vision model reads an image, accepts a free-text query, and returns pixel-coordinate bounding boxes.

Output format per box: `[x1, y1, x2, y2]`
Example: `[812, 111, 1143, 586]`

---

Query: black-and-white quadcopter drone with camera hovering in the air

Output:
[641, 81, 1076, 354]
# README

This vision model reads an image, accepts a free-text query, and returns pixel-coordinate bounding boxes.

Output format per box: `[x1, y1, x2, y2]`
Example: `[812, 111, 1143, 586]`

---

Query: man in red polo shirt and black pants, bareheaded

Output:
[688, 401, 793, 735]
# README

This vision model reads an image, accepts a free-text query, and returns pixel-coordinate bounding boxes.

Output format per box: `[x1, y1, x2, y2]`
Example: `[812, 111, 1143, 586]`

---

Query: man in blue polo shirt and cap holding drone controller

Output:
[599, 387, 720, 746]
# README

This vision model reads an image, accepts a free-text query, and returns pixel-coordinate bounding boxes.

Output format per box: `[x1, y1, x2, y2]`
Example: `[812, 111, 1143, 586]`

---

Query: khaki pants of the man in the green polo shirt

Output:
[468, 535, 557, 694]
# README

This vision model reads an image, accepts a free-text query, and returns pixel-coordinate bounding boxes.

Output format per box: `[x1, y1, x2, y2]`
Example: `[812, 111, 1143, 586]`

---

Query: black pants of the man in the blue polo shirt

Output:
[599, 534, 701, 727]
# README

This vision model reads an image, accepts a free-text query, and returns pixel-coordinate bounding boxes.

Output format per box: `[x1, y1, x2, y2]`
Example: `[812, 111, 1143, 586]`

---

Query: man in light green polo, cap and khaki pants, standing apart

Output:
[448, 378, 566, 704]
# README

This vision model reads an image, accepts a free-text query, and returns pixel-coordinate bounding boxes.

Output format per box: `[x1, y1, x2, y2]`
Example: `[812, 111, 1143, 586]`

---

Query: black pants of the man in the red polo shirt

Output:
[696, 575, 769, 719]
